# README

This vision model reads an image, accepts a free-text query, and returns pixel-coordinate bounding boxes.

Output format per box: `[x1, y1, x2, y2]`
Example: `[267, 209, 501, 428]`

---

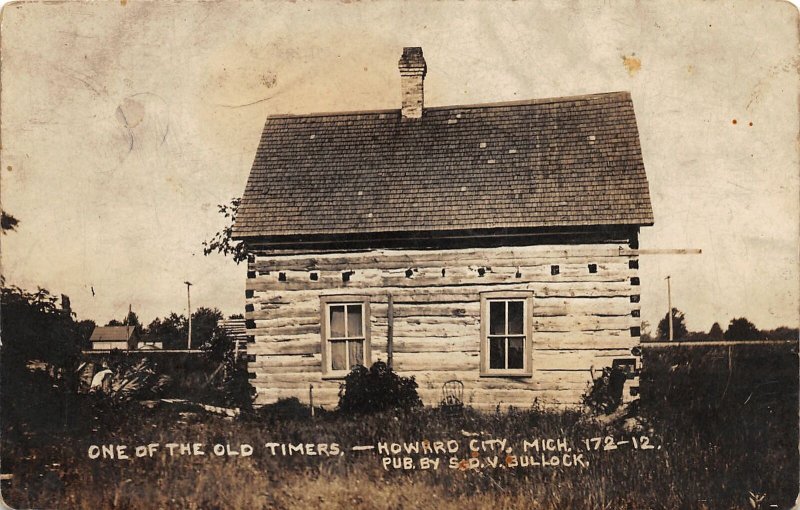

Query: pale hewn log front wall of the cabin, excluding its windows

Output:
[245, 244, 641, 408]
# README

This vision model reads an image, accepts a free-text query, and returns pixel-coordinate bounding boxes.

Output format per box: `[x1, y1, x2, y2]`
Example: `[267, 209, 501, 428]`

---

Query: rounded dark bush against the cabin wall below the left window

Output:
[339, 361, 422, 413]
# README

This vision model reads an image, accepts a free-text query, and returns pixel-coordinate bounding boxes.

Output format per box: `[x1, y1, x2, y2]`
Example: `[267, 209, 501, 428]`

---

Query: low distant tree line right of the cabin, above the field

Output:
[642, 308, 800, 342]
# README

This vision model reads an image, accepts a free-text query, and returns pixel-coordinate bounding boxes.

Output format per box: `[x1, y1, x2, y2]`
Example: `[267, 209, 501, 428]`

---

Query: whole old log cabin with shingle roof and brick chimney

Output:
[234, 48, 653, 408]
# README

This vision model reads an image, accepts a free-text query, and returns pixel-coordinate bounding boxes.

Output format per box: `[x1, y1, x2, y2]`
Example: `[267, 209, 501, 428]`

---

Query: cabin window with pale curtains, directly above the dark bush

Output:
[321, 296, 370, 377]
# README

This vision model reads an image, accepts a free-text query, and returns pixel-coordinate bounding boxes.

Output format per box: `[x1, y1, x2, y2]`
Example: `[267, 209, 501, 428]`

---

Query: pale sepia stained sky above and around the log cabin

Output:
[0, 0, 800, 330]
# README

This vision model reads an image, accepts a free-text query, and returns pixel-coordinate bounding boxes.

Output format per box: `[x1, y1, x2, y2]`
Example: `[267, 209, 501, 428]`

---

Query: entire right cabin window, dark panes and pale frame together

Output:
[481, 291, 533, 376]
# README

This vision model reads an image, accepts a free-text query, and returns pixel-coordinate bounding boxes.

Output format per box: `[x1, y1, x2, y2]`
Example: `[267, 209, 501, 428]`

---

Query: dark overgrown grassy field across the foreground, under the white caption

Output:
[2, 340, 799, 509]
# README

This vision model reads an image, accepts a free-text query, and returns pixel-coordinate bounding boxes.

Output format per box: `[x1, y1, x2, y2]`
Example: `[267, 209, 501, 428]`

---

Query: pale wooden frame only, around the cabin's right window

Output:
[480, 290, 533, 377]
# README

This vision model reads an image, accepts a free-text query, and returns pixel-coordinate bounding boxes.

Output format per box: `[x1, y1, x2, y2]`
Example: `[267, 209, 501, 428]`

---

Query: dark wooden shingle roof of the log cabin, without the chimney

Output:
[233, 92, 653, 239]
